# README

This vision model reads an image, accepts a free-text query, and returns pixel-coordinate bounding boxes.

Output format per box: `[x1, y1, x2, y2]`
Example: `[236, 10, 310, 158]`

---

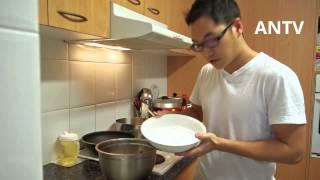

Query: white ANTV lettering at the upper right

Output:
[254, 21, 304, 34]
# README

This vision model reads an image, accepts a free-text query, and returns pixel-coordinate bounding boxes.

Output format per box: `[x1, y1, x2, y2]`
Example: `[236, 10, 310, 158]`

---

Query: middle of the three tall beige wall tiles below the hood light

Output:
[96, 63, 118, 104]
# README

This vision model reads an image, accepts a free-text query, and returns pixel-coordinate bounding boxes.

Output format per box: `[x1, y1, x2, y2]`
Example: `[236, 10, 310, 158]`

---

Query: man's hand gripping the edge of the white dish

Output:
[176, 133, 219, 157]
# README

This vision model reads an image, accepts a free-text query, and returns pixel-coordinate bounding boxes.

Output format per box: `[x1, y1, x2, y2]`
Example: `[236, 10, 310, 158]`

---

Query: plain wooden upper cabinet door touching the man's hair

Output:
[168, 0, 194, 37]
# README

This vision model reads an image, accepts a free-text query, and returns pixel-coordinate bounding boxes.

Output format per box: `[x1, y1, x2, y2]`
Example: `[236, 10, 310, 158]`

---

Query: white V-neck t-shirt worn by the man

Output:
[190, 53, 306, 180]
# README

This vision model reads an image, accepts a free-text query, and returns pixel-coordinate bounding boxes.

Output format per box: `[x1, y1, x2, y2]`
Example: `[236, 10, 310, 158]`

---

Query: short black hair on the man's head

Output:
[185, 0, 241, 25]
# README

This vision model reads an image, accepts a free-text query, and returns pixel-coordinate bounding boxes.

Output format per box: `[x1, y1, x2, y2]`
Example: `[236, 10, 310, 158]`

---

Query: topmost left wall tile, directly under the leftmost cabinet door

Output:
[40, 36, 68, 60]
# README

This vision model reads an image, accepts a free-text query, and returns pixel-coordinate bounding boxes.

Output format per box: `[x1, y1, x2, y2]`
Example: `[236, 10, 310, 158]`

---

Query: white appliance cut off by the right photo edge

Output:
[311, 74, 320, 157]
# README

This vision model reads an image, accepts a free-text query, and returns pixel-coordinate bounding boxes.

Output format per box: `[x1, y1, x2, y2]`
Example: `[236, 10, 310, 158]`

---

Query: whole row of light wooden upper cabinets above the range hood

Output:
[39, 0, 194, 38]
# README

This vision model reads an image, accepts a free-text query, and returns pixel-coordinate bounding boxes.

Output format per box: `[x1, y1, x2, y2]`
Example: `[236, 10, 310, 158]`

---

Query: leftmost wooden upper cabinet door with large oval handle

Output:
[48, 0, 110, 37]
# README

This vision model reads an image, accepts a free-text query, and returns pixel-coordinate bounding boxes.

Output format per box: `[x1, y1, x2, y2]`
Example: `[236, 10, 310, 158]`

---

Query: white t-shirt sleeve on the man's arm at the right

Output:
[266, 69, 306, 125]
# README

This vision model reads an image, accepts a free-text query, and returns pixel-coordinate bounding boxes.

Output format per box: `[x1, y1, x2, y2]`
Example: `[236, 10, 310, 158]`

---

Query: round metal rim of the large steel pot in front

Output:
[95, 138, 156, 159]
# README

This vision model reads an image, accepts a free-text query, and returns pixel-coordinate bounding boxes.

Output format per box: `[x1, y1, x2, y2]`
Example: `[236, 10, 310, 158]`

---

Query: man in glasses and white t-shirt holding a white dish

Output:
[175, 0, 306, 180]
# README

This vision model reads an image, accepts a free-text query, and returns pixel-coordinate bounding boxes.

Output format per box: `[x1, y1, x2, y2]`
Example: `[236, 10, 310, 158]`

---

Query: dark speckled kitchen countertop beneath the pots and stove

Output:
[43, 157, 196, 180]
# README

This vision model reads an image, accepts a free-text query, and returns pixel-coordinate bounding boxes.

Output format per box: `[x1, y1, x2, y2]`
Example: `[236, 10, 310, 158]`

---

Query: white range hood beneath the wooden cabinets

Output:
[84, 2, 192, 50]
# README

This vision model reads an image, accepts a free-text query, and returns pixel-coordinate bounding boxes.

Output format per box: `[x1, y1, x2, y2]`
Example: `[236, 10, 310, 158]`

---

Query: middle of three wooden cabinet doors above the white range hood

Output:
[144, 0, 172, 24]
